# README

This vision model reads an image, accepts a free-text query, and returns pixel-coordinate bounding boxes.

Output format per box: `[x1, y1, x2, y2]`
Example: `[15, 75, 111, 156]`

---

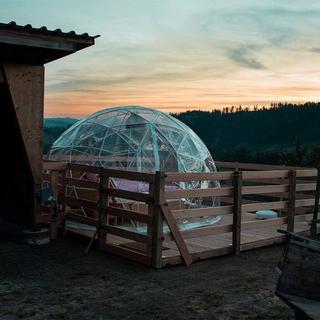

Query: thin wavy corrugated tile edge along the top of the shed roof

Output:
[0, 21, 100, 40]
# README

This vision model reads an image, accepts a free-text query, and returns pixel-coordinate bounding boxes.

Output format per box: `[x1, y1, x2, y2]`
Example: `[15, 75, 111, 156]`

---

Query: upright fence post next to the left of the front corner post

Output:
[97, 169, 110, 249]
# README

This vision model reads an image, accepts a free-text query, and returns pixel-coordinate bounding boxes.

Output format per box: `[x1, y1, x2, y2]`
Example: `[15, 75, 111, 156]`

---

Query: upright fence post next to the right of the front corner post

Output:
[232, 170, 242, 255]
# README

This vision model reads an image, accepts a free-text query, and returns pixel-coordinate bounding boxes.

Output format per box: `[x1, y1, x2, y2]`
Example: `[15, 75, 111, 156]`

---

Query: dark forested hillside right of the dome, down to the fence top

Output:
[172, 102, 320, 165]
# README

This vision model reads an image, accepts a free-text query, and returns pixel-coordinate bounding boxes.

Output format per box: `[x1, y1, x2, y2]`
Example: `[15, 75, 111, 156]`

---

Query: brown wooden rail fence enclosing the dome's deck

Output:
[38, 162, 319, 268]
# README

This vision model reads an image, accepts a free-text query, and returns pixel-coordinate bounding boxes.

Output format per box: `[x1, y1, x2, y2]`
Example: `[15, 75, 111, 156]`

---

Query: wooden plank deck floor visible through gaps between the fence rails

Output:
[69, 213, 320, 266]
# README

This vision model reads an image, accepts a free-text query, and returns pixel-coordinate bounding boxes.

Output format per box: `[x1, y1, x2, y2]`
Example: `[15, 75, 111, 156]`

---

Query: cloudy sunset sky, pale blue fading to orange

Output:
[0, 0, 320, 117]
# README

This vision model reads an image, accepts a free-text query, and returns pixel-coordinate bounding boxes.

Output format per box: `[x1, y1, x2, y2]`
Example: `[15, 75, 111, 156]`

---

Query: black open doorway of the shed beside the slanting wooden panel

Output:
[0, 75, 34, 224]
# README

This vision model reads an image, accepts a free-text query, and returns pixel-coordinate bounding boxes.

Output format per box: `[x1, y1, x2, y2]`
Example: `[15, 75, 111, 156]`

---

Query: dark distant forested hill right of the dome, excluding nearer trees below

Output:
[172, 103, 320, 162]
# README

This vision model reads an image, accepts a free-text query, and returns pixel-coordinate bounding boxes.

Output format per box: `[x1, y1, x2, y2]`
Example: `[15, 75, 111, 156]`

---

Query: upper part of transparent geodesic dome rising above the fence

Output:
[49, 106, 216, 172]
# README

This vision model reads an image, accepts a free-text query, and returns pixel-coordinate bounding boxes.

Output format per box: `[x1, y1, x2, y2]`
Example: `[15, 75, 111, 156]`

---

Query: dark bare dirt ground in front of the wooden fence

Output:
[0, 239, 294, 320]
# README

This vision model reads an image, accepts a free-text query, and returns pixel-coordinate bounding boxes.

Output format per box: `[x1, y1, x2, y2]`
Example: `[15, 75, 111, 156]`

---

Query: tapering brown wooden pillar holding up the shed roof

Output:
[1, 63, 44, 223]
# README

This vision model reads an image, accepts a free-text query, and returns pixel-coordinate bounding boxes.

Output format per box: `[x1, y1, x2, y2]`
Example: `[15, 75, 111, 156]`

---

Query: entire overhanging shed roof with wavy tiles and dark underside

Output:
[0, 21, 99, 65]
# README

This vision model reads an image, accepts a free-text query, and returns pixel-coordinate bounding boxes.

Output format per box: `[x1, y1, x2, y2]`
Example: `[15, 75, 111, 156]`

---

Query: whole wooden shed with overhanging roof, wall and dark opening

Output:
[0, 22, 97, 225]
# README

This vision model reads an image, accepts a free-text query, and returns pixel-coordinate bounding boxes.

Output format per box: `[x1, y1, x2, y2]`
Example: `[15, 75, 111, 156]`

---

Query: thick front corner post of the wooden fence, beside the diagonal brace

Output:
[147, 171, 165, 269]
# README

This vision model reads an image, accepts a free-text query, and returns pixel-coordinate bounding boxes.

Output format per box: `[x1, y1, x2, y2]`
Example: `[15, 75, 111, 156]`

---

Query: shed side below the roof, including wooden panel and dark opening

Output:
[0, 64, 44, 224]
